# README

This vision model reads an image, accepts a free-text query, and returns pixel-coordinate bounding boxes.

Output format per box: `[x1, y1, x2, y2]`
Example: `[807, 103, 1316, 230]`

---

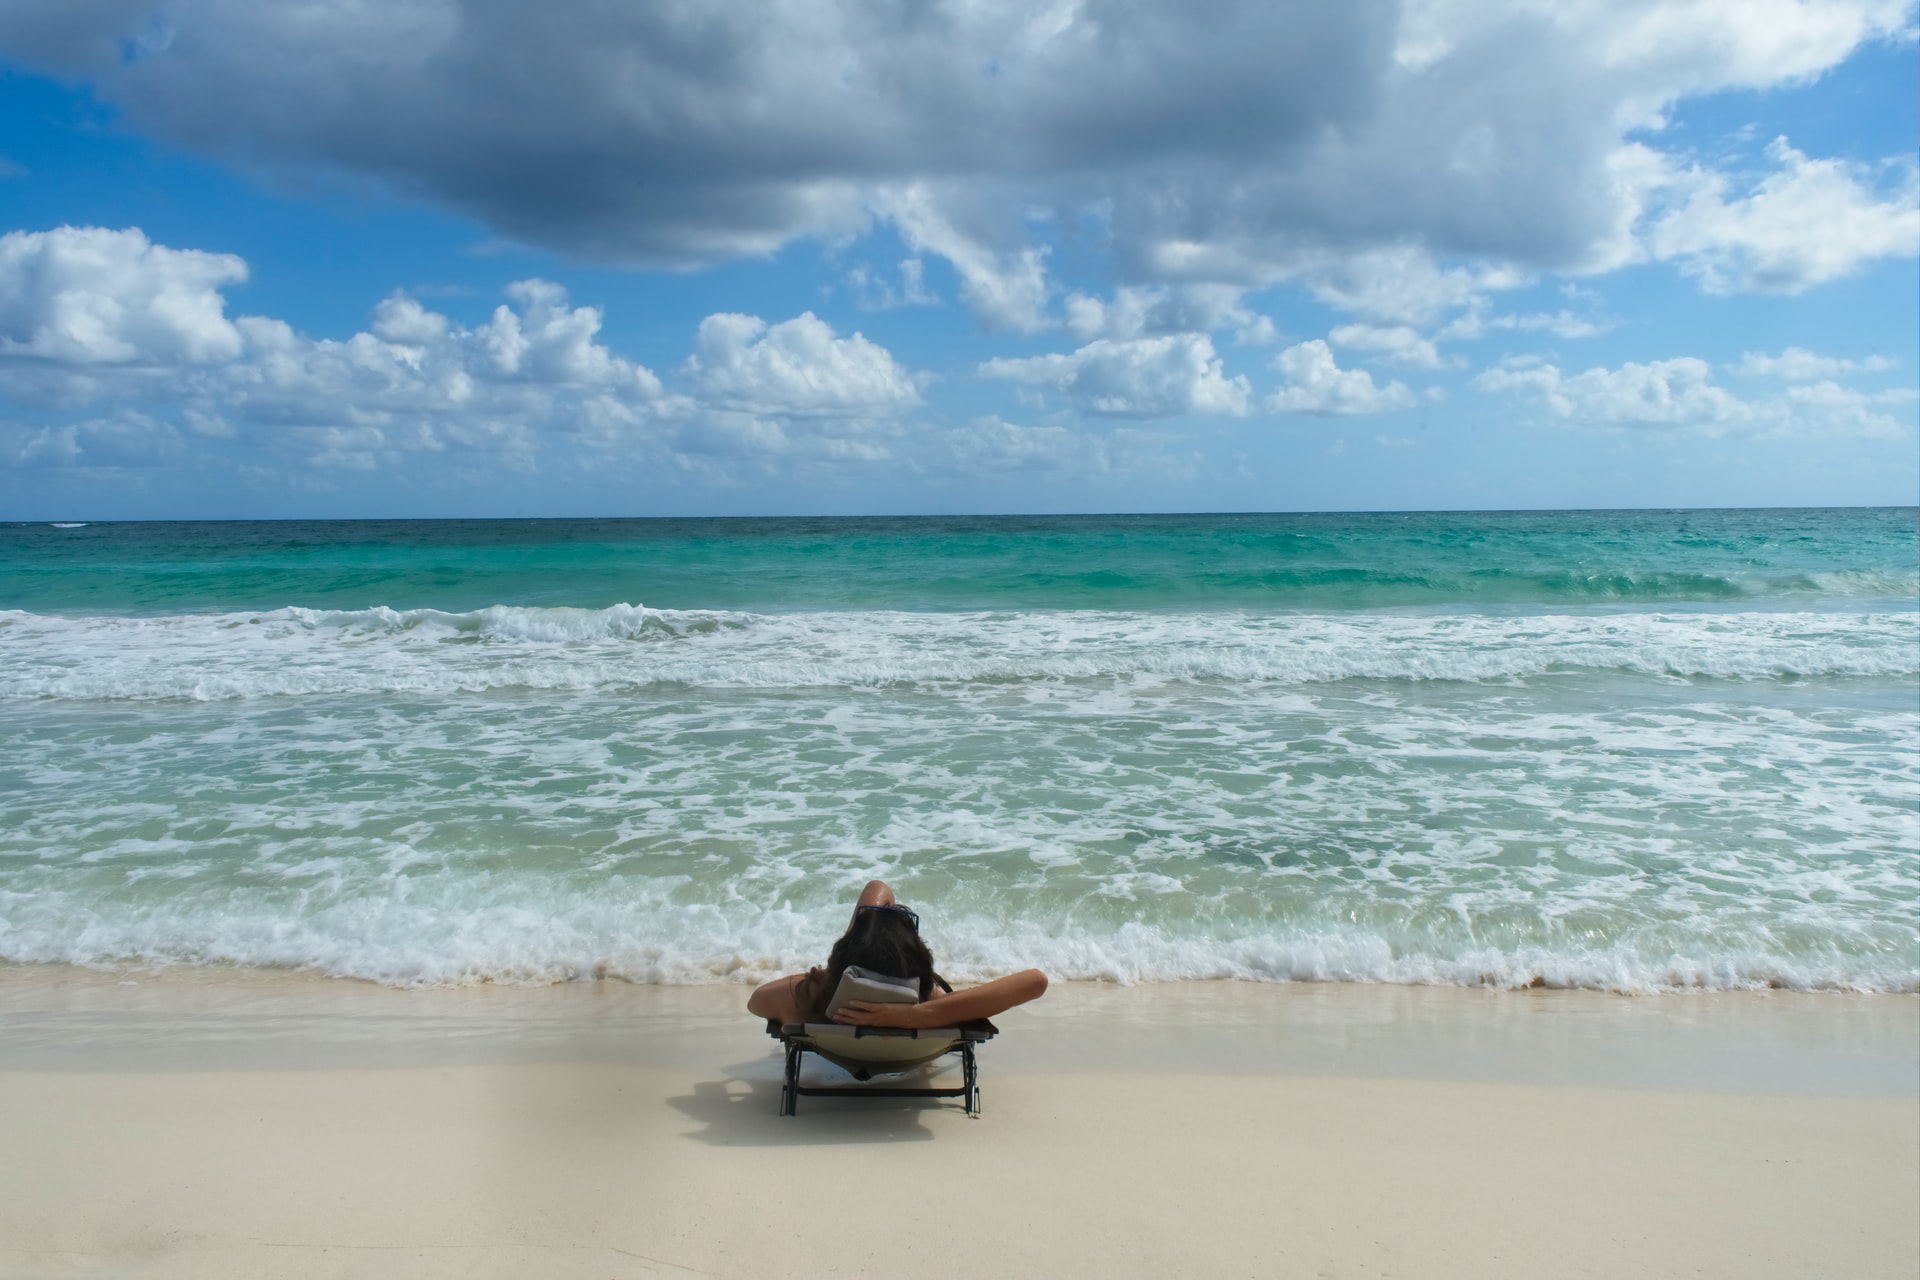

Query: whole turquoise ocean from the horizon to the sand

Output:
[0, 509, 1920, 992]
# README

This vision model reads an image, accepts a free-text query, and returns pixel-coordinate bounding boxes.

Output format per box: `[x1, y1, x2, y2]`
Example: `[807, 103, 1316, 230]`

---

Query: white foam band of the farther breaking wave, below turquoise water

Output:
[0, 604, 1920, 700]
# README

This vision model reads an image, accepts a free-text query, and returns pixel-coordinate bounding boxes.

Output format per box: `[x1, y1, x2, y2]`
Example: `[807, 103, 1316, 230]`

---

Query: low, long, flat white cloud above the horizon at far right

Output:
[1475, 357, 1912, 438]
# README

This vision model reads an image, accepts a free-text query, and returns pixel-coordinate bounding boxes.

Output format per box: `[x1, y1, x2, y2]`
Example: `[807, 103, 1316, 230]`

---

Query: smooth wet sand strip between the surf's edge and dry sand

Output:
[0, 963, 1920, 1096]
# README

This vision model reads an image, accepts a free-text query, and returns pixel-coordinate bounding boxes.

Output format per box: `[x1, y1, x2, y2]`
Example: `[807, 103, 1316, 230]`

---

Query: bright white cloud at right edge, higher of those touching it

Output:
[1647, 138, 1920, 294]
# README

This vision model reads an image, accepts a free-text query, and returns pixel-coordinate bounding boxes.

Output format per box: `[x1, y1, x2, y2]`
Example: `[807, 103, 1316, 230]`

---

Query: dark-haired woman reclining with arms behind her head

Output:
[747, 881, 1046, 1027]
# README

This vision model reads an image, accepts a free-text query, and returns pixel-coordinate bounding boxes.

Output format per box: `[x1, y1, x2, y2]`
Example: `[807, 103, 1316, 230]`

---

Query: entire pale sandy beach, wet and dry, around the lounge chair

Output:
[0, 969, 1920, 1278]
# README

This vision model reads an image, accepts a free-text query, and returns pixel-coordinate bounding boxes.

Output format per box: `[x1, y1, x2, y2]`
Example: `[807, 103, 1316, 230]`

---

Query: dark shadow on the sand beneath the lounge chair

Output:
[666, 1057, 966, 1148]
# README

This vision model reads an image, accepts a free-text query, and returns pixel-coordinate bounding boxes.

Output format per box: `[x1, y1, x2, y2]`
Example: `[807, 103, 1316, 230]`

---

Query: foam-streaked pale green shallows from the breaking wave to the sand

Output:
[0, 606, 1920, 992]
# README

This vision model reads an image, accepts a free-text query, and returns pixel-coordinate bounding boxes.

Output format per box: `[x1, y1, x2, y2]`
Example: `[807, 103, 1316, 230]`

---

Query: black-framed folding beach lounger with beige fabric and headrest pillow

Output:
[766, 965, 998, 1117]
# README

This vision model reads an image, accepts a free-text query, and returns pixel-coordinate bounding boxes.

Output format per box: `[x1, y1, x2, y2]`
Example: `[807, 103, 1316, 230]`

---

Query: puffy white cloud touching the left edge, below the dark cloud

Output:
[0, 226, 246, 367]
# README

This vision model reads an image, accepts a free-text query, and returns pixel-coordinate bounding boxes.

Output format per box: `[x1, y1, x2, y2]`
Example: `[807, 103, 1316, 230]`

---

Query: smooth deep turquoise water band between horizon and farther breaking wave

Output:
[15, 509, 1916, 612]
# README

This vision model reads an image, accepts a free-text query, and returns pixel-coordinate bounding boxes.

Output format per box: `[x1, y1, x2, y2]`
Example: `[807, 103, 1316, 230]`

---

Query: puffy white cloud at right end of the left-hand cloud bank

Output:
[685, 311, 920, 416]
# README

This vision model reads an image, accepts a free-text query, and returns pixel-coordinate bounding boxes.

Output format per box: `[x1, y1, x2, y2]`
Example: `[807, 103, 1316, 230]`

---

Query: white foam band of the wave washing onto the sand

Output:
[0, 898, 1920, 994]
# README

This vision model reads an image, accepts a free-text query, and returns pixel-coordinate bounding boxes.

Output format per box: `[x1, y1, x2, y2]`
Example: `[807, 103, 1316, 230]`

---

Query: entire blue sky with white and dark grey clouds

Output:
[0, 0, 1920, 520]
